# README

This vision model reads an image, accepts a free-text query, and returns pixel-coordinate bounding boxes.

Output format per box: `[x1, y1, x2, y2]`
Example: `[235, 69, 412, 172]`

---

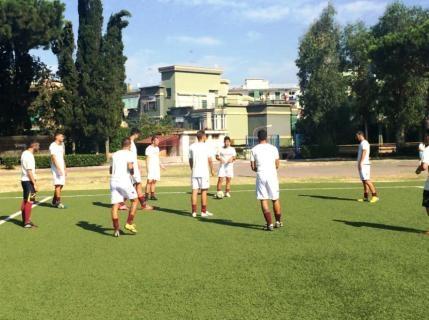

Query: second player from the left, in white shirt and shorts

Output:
[49, 131, 66, 209]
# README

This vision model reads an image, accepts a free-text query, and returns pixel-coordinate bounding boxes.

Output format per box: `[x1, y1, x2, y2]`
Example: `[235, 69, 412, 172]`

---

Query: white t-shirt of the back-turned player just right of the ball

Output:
[250, 143, 280, 177]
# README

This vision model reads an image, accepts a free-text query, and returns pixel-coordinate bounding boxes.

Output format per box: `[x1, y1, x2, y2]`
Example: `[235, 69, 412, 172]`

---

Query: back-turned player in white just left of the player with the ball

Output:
[189, 130, 214, 218]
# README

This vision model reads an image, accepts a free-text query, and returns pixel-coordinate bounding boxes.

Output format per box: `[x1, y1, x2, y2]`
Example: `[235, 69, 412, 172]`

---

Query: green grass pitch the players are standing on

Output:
[0, 182, 429, 319]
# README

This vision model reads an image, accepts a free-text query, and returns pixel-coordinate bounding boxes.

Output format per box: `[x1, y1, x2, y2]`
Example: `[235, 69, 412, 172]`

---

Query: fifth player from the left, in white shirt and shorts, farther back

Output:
[145, 136, 164, 200]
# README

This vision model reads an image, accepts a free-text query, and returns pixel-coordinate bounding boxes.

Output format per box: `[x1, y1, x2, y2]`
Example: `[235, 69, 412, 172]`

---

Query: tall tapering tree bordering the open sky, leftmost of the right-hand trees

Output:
[296, 4, 350, 144]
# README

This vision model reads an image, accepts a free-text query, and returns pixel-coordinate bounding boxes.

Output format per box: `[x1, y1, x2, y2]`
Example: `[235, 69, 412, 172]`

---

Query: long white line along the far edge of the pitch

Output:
[0, 186, 423, 200]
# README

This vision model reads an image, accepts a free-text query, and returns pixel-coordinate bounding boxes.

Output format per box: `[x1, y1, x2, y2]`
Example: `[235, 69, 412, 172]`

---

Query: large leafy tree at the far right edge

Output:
[371, 2, 429, 144]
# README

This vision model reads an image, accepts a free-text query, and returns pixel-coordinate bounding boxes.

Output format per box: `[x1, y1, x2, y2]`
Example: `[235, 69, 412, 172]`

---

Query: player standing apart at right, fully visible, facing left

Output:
[356, 131, 380, 203]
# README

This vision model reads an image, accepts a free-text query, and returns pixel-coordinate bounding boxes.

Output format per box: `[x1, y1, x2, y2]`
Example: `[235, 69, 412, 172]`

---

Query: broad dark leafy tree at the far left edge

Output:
[0, 0, 64, 135]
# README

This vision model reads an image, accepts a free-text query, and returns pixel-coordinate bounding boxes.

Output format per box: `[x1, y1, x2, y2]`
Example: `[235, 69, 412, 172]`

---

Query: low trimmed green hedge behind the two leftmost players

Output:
[1, 154, 106, 169]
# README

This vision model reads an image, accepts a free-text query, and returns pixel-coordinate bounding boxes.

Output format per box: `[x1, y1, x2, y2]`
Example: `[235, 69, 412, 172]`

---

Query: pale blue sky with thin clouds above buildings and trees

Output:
[33, 0, 429, 88]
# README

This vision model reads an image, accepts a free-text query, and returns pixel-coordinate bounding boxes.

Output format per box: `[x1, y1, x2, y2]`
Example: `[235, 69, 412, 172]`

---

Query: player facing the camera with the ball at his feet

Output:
[216, 137, 237, 198]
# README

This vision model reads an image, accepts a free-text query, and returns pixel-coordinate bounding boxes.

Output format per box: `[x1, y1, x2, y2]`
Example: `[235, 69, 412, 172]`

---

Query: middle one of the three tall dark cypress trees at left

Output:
[76, 0, 105, 152]
